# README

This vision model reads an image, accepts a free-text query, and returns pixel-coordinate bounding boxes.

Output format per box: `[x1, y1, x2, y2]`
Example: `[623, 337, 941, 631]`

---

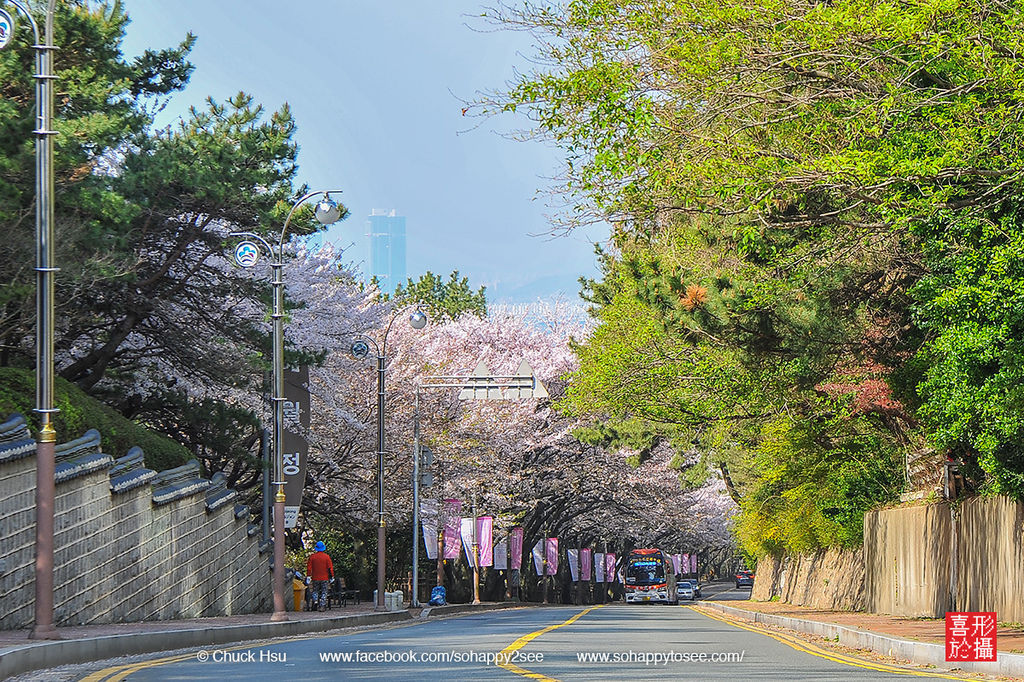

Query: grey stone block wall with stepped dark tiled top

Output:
[0, 409, 270, 629]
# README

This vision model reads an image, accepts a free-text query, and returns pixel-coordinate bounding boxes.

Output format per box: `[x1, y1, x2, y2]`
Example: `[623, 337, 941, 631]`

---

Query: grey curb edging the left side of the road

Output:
[0, 602, 521, 680]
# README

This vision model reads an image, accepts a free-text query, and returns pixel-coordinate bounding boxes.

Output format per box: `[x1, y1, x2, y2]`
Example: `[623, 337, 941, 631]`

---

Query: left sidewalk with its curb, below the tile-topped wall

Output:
[0, 602, 512, 680]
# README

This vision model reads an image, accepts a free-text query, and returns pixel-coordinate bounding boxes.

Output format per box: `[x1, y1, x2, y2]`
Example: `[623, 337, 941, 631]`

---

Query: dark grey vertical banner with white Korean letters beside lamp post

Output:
[282, 367, 309, 528]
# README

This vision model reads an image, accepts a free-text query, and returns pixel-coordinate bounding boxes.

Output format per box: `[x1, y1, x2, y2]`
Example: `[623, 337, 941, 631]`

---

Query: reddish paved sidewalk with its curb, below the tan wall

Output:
[698, 600, 1024, 677]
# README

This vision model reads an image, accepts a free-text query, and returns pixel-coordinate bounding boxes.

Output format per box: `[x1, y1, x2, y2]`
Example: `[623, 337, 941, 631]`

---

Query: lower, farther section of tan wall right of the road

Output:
[751, 549, 864, 610]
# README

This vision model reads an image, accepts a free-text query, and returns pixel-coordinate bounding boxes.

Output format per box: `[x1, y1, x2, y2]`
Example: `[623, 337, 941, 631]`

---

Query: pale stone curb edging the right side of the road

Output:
[700, 601, 1024, 677]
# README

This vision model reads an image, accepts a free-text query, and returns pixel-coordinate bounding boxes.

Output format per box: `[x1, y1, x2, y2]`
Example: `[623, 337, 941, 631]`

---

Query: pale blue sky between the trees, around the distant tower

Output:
[117, 0, 607, 302]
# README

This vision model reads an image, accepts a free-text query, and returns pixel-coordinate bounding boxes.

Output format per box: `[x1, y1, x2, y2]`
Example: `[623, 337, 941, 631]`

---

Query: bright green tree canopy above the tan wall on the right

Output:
[475, 0, 1024, 553]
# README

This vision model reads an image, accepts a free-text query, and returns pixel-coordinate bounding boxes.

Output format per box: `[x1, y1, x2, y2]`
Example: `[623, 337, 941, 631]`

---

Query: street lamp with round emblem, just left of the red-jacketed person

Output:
[230, 189, 342, 621]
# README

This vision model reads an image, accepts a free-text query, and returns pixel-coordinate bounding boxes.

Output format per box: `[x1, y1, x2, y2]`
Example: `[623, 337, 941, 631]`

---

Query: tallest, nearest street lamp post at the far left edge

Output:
[0, 0, 60, 639]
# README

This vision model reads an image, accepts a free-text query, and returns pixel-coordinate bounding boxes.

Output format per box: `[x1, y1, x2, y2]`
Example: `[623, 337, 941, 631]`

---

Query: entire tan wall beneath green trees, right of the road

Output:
[751, 497, 1024, 623]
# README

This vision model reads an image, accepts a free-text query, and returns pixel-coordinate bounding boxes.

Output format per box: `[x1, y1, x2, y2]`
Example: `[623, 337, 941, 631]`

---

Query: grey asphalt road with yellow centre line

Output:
[78, 585, 956, 682]
